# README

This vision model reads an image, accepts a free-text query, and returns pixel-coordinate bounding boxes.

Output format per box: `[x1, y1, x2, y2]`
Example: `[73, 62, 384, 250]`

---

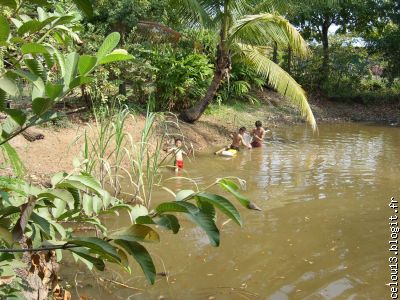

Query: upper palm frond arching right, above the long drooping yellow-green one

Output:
[230, 14, 308, 56]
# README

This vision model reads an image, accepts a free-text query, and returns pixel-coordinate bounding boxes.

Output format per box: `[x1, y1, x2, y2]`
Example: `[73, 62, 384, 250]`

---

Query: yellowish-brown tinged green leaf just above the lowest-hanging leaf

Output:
[109, 224, 160, 242]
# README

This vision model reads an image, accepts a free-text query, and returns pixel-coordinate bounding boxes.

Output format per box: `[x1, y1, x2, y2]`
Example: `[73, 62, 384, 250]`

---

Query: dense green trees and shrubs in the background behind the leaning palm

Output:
[78, 0, 399, 112]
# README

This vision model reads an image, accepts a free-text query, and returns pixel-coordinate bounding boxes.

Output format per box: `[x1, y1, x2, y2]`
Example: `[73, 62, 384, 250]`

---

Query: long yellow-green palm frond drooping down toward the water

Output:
[237, 43, 317, 131]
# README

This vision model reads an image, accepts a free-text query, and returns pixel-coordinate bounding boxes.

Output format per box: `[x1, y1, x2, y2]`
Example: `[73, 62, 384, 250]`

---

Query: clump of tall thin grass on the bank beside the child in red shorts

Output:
[82, 107, 190, 209]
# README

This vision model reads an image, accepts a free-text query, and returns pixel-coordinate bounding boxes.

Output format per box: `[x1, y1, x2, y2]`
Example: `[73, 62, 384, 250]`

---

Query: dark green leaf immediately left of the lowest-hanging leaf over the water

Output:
[68, 237, 121, 262]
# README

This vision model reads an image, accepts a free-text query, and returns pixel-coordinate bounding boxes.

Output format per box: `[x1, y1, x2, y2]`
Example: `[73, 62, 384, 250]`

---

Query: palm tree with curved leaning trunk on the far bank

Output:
[173, 0, 316, 130]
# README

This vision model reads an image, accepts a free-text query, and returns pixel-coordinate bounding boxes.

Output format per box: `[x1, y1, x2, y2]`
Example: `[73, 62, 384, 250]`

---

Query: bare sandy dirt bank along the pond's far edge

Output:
[0, 92, 400, 180]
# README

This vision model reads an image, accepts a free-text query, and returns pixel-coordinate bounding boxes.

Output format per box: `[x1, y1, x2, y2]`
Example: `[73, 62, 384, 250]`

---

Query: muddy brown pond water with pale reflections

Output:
[63, 124, 400, 300]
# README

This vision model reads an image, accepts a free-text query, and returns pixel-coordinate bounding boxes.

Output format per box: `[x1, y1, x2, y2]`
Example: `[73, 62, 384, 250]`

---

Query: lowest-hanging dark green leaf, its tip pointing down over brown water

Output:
[115, 240, 156, 284]
